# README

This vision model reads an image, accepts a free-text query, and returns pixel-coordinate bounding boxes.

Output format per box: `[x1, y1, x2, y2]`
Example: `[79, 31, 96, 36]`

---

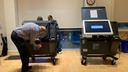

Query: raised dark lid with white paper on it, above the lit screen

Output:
[81, 7, 107, 20]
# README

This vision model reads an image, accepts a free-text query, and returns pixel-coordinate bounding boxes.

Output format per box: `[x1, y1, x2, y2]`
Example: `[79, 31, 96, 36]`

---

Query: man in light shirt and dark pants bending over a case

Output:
[11, 22, 46, 72]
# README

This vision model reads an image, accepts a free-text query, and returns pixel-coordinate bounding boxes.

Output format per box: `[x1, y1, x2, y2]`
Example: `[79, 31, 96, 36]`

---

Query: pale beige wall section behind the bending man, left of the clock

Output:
[18, 0, 82, 28]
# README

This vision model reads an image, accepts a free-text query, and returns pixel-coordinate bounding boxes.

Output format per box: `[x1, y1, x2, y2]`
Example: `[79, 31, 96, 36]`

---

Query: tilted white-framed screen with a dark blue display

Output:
[84, 20, 112, 34]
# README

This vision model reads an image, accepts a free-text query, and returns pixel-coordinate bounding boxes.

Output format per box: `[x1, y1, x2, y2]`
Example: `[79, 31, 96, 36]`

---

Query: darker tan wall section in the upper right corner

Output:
[115, 0, 128, 22]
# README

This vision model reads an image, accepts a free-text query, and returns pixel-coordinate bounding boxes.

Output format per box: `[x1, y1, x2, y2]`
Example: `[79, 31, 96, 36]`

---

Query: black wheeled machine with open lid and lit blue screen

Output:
[80, 7, 120, 65]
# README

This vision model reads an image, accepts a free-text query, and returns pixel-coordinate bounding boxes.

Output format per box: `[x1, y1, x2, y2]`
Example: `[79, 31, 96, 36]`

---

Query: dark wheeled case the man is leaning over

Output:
[23, 21, 58, 65]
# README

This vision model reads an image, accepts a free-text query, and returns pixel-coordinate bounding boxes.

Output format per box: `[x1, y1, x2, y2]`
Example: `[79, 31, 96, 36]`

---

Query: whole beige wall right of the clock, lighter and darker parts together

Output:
[97, 0, 128, 22]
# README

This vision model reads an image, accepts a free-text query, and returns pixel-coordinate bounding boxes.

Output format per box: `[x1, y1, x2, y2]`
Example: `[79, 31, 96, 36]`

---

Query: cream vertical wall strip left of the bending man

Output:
[3, 0, 16, 50]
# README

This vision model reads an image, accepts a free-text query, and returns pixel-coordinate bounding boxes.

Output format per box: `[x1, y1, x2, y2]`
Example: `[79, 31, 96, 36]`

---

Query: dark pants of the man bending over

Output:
[11, 31, 29, 72]
